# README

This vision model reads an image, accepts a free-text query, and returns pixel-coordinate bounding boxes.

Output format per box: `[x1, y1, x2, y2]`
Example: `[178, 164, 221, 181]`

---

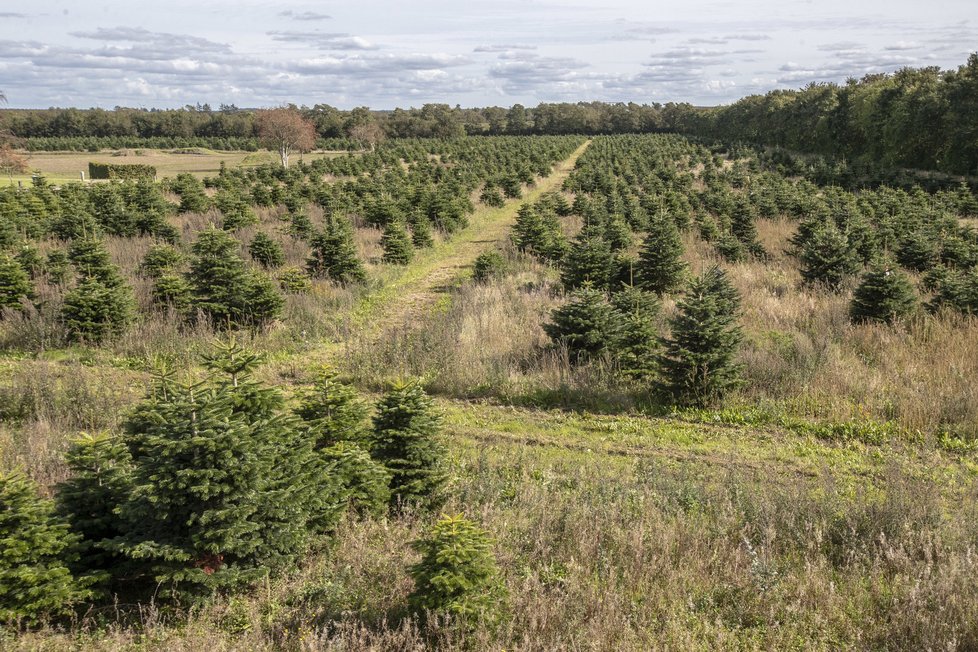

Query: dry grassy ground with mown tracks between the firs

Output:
[0, 136, 978, 651]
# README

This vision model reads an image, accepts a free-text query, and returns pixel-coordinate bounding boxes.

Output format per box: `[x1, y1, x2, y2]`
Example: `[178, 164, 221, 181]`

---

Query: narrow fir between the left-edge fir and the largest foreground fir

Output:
[57, 434, 132, 579]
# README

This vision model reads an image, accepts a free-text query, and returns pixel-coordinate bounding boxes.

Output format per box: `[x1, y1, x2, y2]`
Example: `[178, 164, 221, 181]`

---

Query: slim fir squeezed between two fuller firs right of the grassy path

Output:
[611, 286, 659, 381]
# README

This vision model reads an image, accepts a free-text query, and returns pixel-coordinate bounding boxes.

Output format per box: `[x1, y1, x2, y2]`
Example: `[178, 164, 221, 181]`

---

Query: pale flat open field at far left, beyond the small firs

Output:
[0, 147, 347, 186]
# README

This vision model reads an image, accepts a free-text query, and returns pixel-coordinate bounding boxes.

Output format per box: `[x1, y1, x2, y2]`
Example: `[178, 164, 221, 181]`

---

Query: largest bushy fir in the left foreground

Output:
[116, 340, 320, 600]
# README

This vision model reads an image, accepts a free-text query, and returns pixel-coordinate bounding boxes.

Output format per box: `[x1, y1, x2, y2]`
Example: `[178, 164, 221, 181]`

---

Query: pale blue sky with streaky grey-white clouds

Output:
[0, 0, 978, 109]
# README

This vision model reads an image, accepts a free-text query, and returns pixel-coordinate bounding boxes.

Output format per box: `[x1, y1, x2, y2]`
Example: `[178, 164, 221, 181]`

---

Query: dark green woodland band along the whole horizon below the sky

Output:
[0, 53, 978, 175]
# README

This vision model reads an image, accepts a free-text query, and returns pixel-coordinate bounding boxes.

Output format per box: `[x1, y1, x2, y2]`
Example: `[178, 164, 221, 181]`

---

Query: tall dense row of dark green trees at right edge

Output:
[669, 53, 978, 175]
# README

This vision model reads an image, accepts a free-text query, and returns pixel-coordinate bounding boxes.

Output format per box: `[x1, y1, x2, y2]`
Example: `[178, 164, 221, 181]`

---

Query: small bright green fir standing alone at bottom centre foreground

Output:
[408, 514, 505, 626]
